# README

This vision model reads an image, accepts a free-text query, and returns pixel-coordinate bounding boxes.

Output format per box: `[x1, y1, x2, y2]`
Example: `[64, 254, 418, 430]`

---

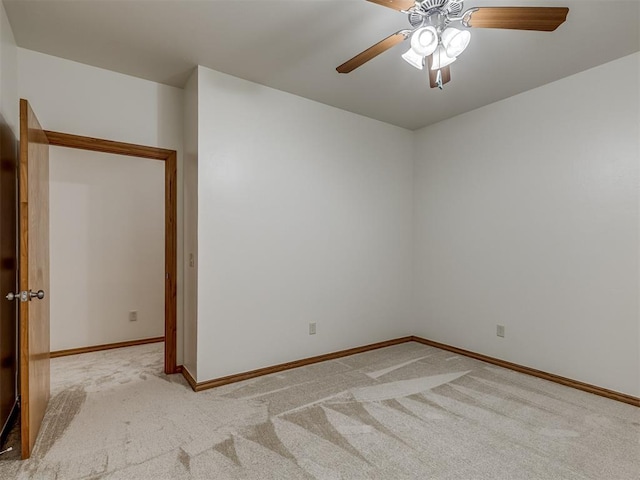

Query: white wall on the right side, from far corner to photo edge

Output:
[415, 54, 640, 395]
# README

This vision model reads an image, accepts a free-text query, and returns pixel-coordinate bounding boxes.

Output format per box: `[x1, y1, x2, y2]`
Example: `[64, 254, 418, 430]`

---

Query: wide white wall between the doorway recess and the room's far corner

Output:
[197, 67, 413, 381]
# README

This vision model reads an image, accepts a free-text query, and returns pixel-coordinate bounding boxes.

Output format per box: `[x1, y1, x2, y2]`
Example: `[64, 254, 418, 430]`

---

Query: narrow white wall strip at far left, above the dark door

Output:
[0, 2, 19, 132]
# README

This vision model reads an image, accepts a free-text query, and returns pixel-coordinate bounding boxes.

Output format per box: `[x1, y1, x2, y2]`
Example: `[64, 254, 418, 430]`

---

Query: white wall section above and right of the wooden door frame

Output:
[18, 48, 184, 363]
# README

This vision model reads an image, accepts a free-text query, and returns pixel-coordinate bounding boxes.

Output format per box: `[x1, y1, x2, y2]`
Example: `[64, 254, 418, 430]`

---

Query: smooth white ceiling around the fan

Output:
[3, 0, 640, 130]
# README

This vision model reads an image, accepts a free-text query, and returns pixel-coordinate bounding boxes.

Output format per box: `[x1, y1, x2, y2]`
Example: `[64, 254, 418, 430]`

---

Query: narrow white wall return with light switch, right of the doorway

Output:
[183, 69, 198, 378]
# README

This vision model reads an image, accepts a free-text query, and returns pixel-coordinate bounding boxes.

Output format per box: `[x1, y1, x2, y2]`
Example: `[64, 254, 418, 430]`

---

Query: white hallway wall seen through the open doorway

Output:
[49, 147, 164, 351]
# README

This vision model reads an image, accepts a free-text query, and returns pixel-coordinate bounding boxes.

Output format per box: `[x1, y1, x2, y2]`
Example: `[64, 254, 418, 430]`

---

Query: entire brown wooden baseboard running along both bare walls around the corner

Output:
[182, 336, 640, 407]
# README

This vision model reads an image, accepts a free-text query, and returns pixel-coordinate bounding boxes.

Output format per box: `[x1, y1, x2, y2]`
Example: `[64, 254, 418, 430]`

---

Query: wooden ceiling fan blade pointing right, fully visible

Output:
[463, 7, 569, 32]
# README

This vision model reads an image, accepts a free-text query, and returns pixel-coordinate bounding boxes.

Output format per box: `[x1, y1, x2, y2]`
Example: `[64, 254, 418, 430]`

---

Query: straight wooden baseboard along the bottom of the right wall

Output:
[412, 336, 640, 407]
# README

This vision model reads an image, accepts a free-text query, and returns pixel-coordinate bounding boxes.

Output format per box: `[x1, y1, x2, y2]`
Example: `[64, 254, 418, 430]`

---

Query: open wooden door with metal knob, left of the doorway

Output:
[19, 100, 50, 459]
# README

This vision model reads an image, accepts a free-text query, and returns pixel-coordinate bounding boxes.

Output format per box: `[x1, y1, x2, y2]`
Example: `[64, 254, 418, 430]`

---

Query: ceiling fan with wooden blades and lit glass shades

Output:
[336, 0, 569, 90]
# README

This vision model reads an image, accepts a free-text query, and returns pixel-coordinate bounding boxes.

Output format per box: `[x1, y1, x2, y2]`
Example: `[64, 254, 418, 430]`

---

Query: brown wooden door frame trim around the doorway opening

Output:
[45, 130, 180, 374]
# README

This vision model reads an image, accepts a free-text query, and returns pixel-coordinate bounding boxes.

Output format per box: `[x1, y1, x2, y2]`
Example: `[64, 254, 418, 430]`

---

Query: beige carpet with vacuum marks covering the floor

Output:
[0, 343, 640, 480]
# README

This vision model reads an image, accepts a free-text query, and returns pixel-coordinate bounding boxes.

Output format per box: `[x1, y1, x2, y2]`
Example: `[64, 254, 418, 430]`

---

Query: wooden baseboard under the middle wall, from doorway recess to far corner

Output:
[183, 337, 412, 392]
